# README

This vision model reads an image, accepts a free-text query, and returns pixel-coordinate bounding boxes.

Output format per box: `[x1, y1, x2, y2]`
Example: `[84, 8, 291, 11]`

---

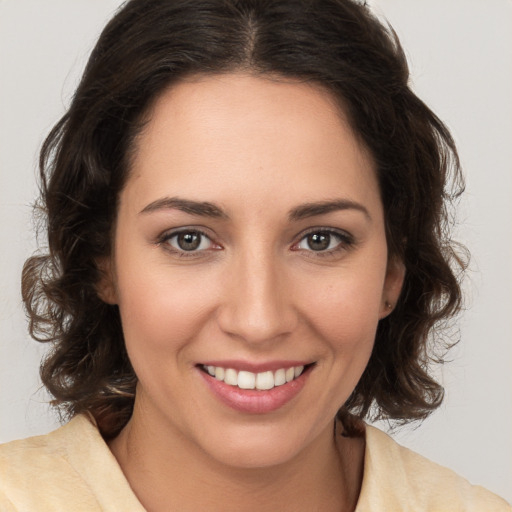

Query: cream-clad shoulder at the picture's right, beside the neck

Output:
[357, 426, 512, 512]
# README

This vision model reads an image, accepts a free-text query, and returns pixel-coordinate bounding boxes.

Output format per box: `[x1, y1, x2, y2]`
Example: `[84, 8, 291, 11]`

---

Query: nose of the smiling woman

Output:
[218, 247, 298, 346]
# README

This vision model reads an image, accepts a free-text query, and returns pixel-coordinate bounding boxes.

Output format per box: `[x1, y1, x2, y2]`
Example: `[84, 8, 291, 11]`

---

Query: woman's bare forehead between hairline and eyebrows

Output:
[124, 73, 378, 216]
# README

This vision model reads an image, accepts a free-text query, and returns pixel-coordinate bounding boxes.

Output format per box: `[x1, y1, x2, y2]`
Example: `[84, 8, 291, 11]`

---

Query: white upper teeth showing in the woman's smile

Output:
[203, 365, 304, 391]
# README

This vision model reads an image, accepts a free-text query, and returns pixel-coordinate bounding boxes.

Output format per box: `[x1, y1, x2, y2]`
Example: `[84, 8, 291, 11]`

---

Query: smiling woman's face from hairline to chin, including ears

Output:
[102, 74, 402, 467]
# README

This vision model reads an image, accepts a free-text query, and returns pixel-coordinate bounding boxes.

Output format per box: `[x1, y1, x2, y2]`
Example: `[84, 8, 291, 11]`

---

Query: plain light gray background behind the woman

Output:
[0, 0, 512, 501]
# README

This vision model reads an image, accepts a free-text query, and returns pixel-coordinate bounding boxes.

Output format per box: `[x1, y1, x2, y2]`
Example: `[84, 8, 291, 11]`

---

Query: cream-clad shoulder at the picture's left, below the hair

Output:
[0, 415, 144, 512]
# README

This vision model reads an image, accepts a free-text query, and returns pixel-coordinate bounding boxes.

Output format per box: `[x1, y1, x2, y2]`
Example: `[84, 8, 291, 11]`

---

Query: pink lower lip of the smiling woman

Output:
[198, 369, 311, 414]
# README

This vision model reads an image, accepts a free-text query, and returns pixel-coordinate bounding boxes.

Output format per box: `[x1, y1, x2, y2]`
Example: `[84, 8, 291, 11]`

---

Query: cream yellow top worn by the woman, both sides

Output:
[0, 415, 512, 512]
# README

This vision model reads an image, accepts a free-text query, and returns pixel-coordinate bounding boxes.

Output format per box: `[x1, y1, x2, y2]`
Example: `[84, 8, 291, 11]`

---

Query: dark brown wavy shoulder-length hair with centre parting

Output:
[22, 0, 464, 438]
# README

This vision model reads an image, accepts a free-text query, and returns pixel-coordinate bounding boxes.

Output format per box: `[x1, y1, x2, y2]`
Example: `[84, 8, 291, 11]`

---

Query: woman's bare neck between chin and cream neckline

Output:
[110, 409, 364, 512]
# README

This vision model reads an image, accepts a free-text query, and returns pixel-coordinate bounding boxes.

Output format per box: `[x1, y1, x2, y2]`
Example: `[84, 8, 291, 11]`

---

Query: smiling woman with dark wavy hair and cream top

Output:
[0, 0, 508, 511]
